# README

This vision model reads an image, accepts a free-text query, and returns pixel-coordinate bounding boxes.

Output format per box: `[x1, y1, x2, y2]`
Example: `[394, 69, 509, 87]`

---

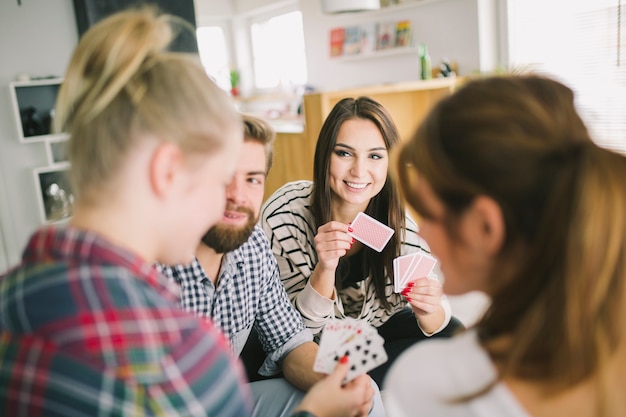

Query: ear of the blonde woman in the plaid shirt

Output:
[149, 142, 183, 197]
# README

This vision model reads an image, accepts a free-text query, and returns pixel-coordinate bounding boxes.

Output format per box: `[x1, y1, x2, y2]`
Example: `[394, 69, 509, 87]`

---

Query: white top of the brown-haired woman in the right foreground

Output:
[384, 330, 531, 417]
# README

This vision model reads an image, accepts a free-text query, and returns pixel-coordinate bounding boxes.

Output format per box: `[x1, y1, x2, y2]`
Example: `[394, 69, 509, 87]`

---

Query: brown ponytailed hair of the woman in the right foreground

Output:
[396, 76, 626, 416]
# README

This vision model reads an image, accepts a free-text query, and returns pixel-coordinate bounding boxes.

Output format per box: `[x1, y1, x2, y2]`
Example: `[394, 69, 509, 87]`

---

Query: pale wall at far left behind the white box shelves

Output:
[0, 0, 78, 272]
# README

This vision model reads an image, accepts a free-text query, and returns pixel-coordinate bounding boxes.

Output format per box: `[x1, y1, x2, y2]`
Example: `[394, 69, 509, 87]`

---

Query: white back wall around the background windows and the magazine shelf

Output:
[195, 0, 501, 90]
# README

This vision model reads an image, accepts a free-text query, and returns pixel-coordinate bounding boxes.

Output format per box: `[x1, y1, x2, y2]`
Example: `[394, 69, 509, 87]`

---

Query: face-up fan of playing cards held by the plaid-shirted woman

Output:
[313, 317, 387, 382]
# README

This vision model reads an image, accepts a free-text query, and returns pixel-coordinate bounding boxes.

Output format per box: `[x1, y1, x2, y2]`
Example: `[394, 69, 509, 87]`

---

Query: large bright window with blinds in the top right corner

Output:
[507, 0, 626, 153]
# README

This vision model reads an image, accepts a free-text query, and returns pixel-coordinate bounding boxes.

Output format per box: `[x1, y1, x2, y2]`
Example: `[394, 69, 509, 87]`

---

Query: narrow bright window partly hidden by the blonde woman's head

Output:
[196, 26, 230, 91]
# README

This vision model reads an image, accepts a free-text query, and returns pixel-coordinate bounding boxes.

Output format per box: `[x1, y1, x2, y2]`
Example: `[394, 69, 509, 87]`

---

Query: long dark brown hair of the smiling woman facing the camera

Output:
[311, 97, 405, 309]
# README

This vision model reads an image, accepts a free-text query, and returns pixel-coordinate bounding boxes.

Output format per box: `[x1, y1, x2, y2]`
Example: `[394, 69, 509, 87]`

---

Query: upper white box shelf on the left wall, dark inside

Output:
[9, 78, 67, 143]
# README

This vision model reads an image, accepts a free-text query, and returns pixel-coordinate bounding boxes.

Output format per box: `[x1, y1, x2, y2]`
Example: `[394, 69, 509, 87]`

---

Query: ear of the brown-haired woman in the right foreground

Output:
[470, 196, 506, 255]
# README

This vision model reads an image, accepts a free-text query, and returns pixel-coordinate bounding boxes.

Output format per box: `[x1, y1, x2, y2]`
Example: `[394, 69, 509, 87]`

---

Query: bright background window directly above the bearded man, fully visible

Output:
[250, 11, 307, 89]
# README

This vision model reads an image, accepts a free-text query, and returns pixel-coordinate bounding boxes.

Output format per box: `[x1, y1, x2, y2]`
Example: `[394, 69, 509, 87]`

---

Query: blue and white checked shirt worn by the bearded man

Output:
[159, 226, 313, 376]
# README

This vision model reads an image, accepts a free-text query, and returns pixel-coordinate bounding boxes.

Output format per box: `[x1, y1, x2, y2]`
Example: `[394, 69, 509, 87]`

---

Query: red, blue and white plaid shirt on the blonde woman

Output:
[0, 227, 251, 417]
